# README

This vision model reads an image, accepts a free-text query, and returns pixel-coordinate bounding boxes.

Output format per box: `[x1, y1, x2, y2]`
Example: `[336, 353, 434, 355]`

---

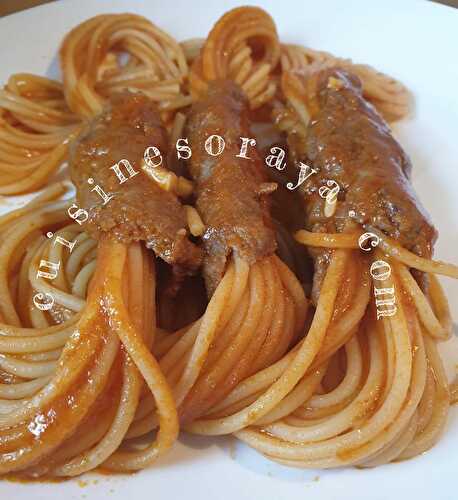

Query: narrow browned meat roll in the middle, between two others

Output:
[185, 81, 276, 293]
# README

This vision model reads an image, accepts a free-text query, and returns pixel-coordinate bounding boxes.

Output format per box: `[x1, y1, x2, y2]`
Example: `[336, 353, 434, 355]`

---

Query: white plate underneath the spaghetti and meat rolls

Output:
[0, 0, 458, 500]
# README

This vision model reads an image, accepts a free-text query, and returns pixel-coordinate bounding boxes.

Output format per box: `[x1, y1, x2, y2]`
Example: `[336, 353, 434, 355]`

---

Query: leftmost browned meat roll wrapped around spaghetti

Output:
[70, 93, 202, 274]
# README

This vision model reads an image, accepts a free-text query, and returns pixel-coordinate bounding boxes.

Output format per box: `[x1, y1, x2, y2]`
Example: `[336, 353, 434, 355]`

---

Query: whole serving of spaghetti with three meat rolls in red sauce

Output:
[0, 7, 458, 478]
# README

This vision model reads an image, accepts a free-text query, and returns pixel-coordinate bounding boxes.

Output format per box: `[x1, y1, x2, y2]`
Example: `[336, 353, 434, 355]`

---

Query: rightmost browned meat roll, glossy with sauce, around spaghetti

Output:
[292, 69, 437, 257]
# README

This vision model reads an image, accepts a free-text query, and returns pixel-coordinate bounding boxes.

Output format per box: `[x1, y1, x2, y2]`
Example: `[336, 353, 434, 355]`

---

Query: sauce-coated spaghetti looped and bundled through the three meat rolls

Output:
[0, 7, 458, 477]
